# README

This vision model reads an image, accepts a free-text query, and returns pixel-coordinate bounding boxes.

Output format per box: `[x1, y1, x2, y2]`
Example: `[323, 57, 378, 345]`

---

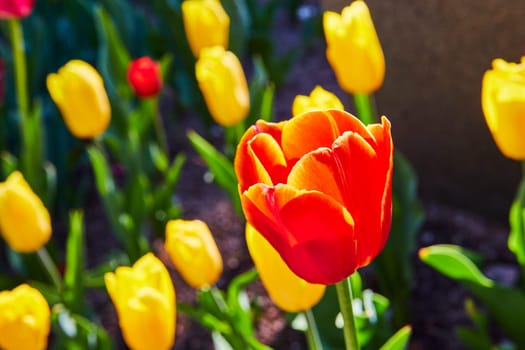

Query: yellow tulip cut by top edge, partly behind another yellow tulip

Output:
[182, 0, 230, 57]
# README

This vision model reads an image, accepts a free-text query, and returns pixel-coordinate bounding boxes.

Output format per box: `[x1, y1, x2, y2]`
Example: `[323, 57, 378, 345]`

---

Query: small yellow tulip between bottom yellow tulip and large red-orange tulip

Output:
[164, 220, 222, 289]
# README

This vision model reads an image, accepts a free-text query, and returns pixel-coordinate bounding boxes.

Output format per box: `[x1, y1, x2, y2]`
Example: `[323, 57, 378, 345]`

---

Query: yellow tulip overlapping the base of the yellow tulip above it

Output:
[195, 46, 250, 126]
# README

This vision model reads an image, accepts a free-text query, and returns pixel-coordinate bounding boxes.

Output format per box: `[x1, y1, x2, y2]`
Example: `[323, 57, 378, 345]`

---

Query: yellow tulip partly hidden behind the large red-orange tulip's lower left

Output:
[246, 224, 326, 312]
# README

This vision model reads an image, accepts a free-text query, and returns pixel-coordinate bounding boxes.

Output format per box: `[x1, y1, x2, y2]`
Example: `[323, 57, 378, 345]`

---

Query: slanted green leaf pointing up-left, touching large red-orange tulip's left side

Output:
[188, 131, 242, 215]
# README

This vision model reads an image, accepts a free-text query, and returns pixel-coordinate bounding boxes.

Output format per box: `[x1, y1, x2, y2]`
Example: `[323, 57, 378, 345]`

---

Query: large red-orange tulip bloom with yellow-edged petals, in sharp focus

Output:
[235, 109, 394, 284]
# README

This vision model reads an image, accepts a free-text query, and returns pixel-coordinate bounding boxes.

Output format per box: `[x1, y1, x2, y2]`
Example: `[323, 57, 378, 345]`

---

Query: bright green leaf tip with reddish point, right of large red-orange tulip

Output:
[419, 244, 494, 287]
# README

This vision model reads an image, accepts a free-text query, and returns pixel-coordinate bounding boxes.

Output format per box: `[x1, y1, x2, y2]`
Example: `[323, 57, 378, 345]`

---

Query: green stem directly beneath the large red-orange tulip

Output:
[335, 277, 360, 350]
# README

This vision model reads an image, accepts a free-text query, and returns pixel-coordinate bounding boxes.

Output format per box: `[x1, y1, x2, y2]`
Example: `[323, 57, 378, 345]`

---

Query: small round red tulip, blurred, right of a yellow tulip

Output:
[128, 57, 162, 98]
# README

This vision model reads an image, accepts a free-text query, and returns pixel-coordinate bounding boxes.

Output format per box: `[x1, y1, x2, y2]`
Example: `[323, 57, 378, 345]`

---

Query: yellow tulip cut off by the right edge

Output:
[481, 56, 525, 160]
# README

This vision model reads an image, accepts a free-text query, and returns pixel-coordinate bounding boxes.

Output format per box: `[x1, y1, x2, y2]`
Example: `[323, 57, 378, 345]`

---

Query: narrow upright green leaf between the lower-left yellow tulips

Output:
[64, 211, 85, 313]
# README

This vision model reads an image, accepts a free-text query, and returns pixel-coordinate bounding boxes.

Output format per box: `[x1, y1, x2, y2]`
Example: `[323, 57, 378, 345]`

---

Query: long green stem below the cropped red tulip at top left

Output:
[8, 19, 42, 195]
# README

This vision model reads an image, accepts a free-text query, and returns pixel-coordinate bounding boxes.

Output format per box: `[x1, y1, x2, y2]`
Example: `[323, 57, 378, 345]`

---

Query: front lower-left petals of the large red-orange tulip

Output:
[243, 184, 357, 284]
